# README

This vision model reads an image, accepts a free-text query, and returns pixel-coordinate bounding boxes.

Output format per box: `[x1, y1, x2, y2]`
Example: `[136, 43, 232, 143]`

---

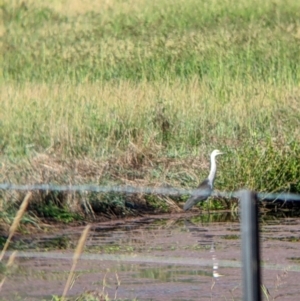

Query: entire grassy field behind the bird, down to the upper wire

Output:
[0, 0, 300, 218]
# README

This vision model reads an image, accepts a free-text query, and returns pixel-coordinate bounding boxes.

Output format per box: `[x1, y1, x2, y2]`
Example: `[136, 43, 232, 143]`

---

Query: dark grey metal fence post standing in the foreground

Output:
[240, 190, 261, 301]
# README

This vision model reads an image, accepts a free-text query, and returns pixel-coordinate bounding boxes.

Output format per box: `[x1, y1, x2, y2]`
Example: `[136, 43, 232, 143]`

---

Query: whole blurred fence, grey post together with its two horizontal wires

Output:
[0, 183, 300, 301]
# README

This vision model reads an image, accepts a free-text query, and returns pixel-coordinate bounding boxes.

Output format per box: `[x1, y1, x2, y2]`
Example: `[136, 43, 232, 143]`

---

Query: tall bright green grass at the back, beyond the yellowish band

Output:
[3, 0, 300, 84]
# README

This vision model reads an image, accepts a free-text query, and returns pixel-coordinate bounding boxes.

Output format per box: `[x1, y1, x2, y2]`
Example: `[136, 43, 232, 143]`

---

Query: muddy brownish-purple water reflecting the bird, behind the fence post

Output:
[0, 214, 300, 301]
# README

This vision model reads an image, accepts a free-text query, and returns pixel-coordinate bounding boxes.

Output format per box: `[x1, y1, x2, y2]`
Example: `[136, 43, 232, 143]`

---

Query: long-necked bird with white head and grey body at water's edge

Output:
[183, 149, 223, 211]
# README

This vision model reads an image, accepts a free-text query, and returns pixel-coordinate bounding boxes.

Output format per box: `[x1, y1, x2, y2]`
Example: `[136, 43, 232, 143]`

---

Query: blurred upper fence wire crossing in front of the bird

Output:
[0, 183, 300, 201]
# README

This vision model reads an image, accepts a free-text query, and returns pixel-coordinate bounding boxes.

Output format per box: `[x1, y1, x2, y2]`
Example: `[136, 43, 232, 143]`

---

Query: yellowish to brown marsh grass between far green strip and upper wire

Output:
[0, 79, 300, 191]
